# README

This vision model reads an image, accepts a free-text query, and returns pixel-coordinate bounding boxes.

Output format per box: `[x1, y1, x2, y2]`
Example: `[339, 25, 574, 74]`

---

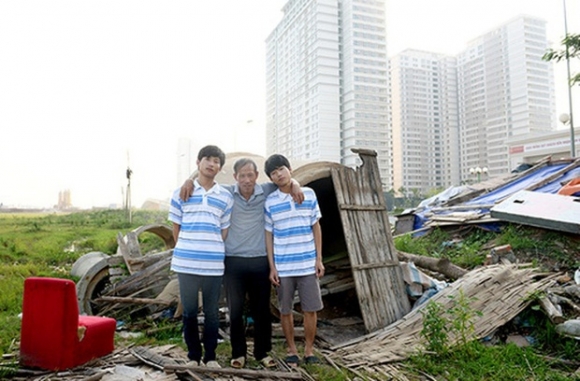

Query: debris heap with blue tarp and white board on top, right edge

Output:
[395, 157, 580, 235]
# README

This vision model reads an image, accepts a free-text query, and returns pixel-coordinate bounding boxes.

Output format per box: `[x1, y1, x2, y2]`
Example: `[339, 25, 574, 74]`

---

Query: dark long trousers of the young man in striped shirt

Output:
[177, 273, 222, 363]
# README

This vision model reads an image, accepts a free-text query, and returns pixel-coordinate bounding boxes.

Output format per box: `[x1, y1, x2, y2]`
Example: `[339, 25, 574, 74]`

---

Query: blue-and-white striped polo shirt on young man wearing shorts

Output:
[264, 187, 322, 278]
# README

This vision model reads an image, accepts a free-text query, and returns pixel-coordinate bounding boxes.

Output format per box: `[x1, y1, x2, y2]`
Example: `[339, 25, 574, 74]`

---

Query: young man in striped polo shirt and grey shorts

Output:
[264, 155, 324, 366]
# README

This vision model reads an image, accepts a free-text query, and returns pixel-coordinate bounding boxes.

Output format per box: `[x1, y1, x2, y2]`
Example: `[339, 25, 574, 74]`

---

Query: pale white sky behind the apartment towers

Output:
[0, 0, 580, 208]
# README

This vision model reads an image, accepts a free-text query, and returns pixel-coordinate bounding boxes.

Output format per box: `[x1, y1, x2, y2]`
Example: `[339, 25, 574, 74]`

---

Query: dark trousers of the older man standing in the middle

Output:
[224, 256, 272, 360]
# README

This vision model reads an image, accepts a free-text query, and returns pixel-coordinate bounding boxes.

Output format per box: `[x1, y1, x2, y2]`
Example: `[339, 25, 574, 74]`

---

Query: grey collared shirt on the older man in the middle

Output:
[224, 183, 278, 258]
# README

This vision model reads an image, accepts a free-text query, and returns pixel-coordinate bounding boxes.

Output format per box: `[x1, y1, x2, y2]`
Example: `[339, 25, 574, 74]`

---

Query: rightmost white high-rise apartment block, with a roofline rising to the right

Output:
[457, 16, 556, 180]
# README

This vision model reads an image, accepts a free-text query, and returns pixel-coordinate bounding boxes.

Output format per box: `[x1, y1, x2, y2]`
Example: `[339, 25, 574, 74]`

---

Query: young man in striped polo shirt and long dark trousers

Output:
[169, 146, 233, 367]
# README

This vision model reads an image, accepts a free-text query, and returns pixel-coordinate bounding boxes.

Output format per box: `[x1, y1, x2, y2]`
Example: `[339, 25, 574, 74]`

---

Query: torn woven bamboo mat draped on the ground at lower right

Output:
[331, 264, 558, 374]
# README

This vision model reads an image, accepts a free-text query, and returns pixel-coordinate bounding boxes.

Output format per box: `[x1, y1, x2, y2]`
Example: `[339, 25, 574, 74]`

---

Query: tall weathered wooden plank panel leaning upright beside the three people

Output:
[331, 150, 410, 332]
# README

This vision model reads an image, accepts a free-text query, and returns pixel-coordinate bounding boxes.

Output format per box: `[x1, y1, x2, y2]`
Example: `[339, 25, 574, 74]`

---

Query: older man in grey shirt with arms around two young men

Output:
[180, 158, 304, 368]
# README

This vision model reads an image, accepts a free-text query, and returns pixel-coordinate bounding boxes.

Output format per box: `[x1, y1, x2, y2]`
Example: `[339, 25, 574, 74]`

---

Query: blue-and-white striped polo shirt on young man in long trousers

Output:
[169, 180, 234, 276]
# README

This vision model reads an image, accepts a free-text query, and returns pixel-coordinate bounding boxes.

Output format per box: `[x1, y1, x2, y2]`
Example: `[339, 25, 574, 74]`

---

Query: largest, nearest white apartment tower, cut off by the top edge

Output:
[266, 0, 391, 188]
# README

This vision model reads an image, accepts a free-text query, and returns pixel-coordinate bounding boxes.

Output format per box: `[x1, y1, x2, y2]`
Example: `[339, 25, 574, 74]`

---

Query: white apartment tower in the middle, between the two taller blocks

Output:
[390, 50, 460, 194]
